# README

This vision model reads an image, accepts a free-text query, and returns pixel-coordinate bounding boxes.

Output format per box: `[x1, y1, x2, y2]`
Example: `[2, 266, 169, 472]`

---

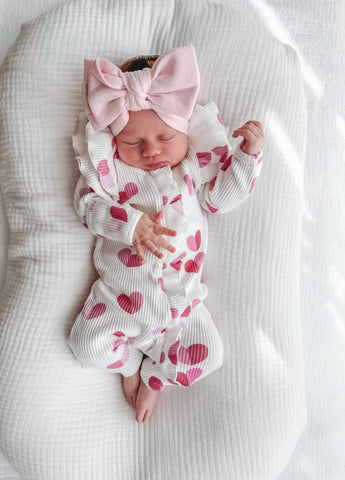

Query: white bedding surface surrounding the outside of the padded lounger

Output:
[0, 0, 345, 480]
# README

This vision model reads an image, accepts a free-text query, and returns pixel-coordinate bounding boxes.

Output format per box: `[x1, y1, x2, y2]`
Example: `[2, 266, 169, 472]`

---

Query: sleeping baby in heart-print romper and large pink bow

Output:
[68, 46, 264, 422]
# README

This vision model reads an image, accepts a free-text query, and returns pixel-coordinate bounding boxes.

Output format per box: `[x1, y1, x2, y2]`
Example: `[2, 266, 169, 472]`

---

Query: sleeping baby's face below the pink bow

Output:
[116, 110, 188, 170]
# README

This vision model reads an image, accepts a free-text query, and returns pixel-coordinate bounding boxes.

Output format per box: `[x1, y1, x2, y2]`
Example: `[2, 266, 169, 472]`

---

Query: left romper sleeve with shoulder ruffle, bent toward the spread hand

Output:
[73, 115, 143, 245]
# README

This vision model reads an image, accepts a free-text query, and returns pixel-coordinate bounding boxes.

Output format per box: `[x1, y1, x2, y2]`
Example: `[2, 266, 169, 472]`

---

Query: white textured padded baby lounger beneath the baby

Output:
[0, 0, 306, 480]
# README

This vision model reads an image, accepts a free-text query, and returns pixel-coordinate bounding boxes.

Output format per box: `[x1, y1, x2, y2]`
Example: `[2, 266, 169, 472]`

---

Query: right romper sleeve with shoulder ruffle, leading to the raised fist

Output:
[189, 102, 262, 213]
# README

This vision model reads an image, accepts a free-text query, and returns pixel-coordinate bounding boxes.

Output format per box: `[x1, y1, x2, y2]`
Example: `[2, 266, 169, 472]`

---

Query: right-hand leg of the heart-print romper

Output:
[141, 304, 223, 390]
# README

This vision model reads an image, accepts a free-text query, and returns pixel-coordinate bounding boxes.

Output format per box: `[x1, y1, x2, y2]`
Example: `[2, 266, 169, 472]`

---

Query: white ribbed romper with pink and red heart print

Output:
[68, 102, 262, 390]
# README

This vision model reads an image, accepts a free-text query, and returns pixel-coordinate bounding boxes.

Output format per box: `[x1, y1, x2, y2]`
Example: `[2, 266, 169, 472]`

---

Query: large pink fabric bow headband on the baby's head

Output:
[84, 46, 199, 135]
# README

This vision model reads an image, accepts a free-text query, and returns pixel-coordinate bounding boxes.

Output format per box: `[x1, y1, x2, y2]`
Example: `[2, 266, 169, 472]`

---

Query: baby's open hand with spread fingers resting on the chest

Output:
[132, 211, 176, 263]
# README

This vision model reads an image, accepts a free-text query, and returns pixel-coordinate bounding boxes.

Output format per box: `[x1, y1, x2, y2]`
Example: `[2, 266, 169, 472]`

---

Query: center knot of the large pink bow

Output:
[121, 68, 151, 111]
